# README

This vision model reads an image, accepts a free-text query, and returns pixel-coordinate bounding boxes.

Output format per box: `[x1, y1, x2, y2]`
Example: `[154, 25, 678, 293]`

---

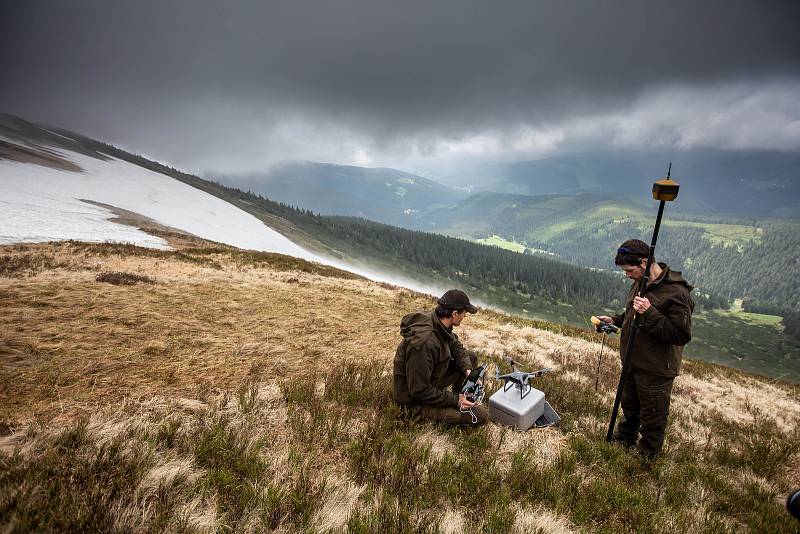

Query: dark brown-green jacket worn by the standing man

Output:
[613, 263, 694, 377]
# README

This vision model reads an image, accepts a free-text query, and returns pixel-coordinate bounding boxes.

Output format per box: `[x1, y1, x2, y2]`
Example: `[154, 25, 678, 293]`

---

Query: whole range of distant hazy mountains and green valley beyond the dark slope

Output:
[205, 149, 800, 318]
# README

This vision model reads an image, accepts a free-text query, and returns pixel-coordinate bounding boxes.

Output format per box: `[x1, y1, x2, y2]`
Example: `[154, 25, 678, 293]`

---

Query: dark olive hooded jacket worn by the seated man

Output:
[394, 312, 471, 408]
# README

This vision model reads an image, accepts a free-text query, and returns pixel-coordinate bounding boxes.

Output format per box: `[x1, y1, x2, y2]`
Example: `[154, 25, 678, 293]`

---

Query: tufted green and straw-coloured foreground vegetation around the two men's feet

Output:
[0, 358, 800, 532]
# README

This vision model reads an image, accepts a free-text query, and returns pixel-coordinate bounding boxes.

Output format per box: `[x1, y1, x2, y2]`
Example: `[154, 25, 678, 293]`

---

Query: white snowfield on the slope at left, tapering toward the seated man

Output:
[0, 151, 440, 294]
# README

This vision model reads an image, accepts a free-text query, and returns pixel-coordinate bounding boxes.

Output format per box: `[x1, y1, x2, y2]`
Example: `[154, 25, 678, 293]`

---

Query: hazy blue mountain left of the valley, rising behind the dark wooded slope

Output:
[215, 161, 466, 227]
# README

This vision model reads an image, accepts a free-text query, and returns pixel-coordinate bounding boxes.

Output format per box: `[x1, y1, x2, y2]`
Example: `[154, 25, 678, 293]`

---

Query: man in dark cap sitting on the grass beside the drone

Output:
[394, 289, 489, 426]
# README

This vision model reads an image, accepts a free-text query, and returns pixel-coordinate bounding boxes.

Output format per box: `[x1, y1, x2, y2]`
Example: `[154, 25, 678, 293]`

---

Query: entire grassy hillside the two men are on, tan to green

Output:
[0, 241, 800, 532]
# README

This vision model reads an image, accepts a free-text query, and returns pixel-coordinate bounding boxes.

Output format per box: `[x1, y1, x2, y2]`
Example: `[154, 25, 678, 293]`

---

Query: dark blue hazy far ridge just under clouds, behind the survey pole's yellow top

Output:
[445, 149, 800, 219]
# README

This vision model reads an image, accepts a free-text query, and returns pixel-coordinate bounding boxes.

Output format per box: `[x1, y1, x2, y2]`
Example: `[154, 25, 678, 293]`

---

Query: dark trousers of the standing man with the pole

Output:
[614, 371, 675, 457]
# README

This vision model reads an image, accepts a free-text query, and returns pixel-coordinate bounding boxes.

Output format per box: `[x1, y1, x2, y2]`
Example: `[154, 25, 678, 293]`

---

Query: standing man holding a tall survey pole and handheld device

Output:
[598, 239, 694, 458]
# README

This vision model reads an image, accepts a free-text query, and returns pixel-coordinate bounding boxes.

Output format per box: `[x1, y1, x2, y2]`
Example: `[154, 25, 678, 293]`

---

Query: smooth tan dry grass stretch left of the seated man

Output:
[0, 245, 410, 424]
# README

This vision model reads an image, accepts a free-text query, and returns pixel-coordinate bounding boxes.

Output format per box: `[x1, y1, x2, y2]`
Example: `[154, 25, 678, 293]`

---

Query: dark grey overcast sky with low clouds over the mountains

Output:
[0, 0, 800, 175]
